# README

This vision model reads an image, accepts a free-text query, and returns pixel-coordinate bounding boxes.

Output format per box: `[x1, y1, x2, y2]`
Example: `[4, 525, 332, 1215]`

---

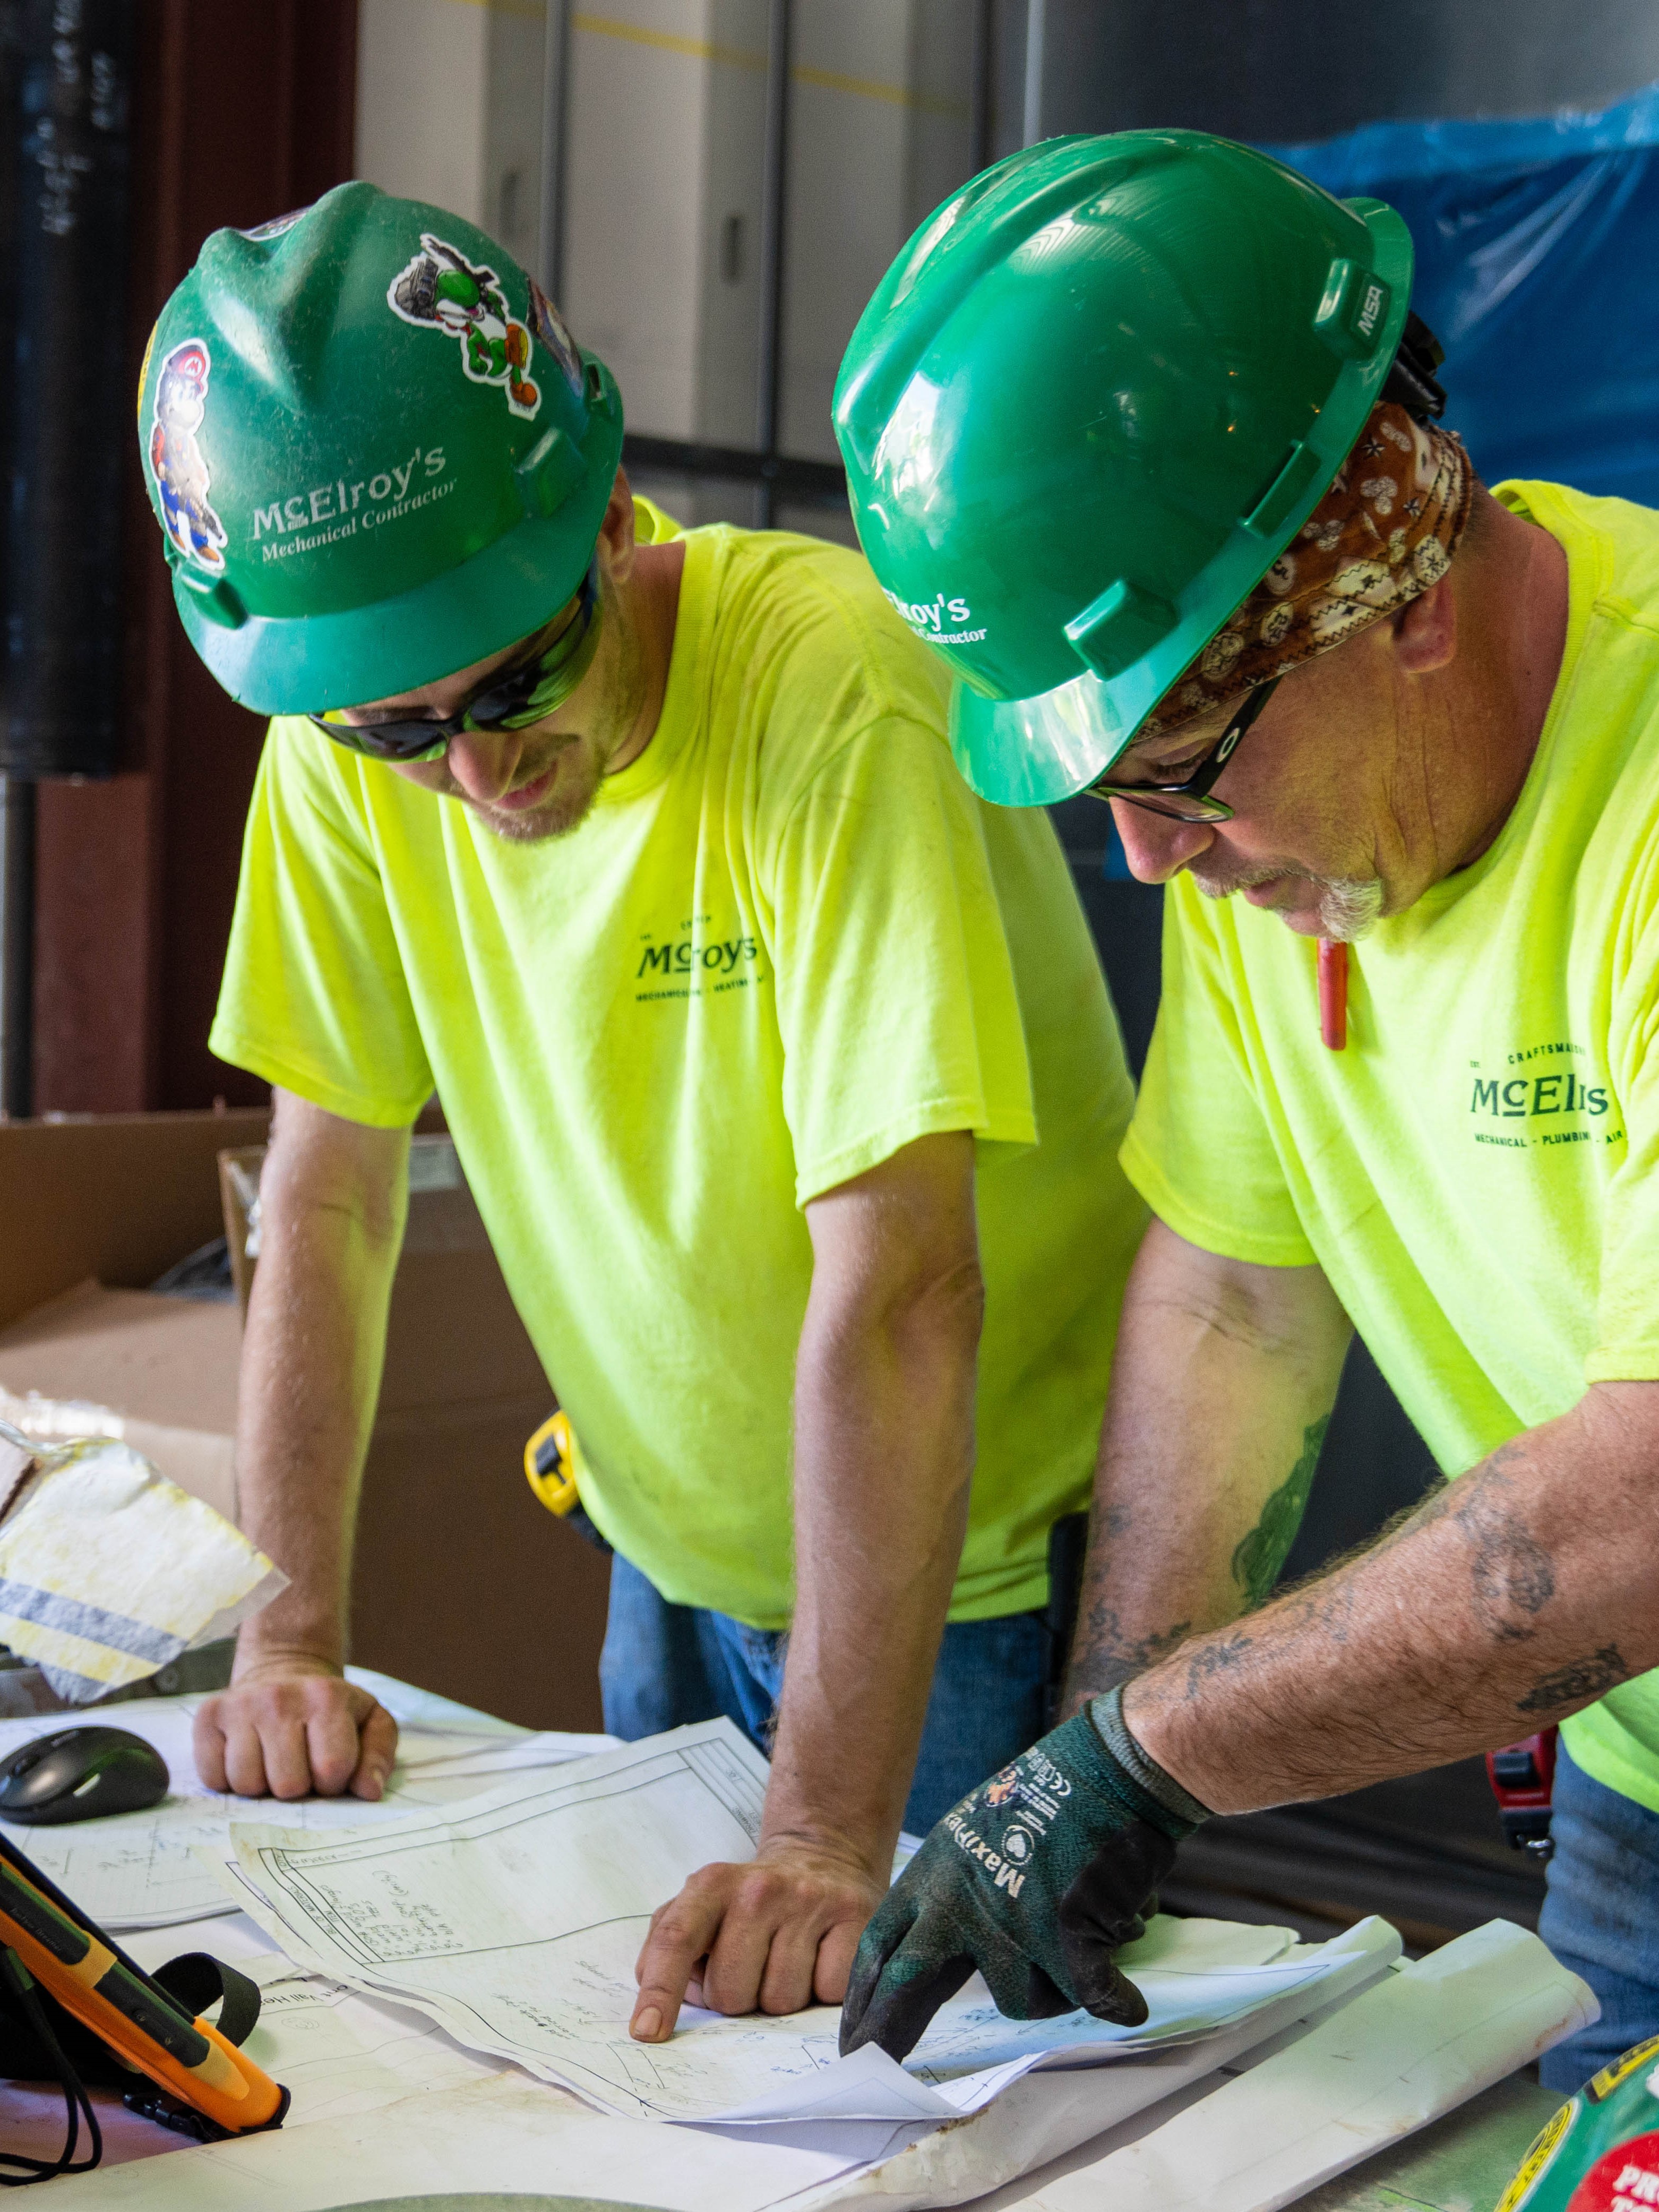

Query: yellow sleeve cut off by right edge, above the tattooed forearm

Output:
[1584, 885, 1659, 1383]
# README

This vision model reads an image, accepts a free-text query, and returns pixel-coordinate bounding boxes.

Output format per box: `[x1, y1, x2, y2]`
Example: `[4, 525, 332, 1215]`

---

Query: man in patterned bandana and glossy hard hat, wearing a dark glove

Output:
[836, 131, 1659, 2086]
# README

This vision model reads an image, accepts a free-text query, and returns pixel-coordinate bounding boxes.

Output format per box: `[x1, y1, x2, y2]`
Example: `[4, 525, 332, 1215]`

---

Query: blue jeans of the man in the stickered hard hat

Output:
[599, 1557, 1051, 1836]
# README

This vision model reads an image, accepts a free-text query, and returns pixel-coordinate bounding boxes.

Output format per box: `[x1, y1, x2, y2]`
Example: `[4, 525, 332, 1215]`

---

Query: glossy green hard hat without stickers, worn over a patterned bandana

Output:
[834, 131, 1411, 805]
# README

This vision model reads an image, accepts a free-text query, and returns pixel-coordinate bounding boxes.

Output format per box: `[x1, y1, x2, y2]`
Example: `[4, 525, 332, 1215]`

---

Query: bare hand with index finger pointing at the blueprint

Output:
[628, 1840, 887, 2044]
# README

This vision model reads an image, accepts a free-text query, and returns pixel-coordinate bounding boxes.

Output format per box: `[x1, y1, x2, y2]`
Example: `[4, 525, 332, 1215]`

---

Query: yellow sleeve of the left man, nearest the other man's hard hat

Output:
[763, 715, 1037, 1205]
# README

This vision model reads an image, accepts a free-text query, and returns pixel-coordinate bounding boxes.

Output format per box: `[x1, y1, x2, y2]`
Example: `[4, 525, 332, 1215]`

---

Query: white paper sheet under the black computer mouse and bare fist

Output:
[0, 1696, 611, 1931]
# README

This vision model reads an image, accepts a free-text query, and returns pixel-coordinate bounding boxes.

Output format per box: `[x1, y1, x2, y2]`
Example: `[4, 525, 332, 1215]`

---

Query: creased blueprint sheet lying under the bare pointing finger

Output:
[233, 1721, 792, 2117]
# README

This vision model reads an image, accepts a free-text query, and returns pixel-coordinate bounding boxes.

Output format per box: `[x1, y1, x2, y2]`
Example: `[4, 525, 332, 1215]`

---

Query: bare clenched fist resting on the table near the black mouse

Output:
[195, 1657, 398, 1801]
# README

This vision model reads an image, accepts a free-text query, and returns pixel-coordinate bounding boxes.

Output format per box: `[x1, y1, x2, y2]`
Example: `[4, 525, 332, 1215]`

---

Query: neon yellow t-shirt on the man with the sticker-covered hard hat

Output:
[212, 502, 1146, 1628]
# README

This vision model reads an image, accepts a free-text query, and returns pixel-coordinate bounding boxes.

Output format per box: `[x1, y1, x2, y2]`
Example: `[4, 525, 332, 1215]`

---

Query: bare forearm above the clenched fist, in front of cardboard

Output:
[237, 1100, 402, 1672]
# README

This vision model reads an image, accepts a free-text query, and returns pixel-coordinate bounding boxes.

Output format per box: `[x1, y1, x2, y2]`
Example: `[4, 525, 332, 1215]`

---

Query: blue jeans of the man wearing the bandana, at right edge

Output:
[1537, 1745, 1659, 2090]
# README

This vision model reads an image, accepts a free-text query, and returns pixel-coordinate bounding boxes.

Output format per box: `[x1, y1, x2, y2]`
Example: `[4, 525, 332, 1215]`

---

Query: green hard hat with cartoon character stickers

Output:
[140, 184, 622, 715]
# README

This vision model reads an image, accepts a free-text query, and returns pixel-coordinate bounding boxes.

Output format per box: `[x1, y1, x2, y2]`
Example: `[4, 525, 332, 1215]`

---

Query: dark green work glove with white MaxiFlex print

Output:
[840, 1690, 1210, 2060]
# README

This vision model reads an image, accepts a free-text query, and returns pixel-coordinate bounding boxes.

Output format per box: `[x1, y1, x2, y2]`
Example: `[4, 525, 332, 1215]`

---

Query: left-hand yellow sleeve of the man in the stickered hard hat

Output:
[208, 721, 434, 1128]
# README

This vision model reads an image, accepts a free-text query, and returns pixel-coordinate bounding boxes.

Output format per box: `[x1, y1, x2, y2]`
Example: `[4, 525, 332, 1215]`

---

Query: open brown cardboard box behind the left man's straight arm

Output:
[0, 1112, 611, 1728]
